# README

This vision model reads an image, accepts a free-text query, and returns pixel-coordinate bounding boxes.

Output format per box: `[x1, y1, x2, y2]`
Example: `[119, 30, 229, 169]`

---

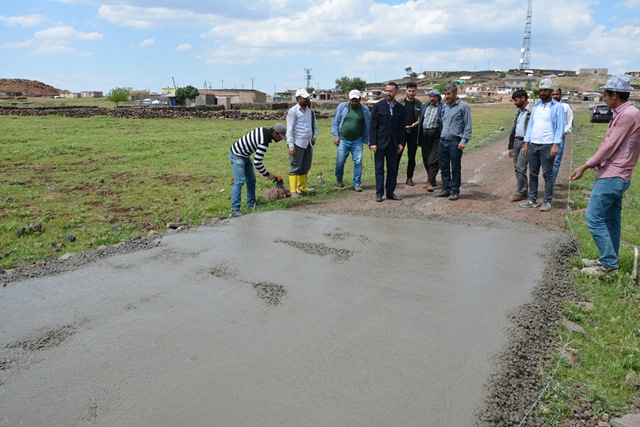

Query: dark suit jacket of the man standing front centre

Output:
[369, 98, 406, 150]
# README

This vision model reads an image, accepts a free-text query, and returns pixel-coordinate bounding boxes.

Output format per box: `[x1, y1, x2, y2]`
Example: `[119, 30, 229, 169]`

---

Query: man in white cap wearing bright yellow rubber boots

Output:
[287, 89, 318, 197]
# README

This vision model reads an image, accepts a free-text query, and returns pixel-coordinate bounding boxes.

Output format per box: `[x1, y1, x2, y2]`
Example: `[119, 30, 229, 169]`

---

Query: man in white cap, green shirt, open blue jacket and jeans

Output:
[331, 89, 371, 192]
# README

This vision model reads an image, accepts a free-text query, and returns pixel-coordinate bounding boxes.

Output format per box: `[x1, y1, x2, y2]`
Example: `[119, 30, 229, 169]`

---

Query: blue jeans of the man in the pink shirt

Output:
[584, 178, 631, 268]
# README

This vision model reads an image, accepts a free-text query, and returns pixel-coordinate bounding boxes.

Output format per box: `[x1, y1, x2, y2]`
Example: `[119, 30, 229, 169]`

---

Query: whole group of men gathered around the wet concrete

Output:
[229, 75, 640, 276]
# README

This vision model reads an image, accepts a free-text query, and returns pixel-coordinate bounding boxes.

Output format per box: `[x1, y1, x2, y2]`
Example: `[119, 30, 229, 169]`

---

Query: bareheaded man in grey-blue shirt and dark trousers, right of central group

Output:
[435, 83, 471, 200]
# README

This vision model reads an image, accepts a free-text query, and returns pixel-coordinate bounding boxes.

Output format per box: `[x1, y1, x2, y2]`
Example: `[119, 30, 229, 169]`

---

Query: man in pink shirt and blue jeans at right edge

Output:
[571, 75, 640, 276]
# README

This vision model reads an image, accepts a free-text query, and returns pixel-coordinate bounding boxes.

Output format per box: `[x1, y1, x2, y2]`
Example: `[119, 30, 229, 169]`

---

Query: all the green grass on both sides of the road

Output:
[0, 105, 640, 426]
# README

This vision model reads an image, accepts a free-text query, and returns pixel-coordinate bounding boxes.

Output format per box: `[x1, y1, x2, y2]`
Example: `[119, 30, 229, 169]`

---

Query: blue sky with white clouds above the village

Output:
[0, 0, 640, 94]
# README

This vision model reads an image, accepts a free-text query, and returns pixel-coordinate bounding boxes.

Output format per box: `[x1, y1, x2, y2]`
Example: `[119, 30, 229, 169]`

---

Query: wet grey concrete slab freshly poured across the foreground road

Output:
[0, 212, 553, 426]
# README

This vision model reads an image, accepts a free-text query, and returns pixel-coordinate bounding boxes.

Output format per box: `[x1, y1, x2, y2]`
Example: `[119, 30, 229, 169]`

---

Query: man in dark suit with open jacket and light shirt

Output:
[369, 82, 406, 202]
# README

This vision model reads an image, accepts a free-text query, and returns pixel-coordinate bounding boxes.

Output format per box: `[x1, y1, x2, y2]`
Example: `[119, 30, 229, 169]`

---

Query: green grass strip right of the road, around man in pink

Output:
[540, 105, 640, 426]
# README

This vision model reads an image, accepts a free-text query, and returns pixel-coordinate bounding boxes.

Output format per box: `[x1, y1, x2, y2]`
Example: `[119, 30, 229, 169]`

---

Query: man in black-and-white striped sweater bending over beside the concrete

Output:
[229, 123, 287, 217]
